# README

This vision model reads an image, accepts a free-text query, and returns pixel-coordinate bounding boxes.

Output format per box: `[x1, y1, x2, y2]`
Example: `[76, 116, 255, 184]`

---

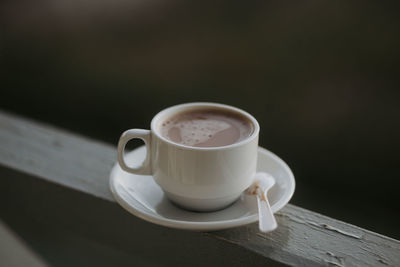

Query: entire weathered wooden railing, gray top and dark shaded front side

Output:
[0, 112, 400, 266]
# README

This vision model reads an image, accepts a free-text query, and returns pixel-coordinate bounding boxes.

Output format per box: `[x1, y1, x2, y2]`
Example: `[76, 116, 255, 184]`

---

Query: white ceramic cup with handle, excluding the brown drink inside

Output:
[118, 103, 260, 211]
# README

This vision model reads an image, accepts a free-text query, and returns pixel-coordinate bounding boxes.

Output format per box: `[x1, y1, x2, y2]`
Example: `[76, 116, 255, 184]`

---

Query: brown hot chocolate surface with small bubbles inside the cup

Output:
[161, 109, 253, 147]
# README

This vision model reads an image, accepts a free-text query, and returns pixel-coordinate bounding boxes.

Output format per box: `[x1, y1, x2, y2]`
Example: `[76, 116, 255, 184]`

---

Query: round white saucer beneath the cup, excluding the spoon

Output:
[110, 147, 295, 231]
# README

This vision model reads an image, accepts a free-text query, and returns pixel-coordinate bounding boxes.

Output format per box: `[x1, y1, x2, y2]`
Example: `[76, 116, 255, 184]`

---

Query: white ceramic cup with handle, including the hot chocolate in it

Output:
[118, 103, 260, 211]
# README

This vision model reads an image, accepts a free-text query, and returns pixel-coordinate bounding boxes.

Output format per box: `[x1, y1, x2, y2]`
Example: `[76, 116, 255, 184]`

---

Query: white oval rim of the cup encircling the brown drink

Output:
[150, 102, 260, 151]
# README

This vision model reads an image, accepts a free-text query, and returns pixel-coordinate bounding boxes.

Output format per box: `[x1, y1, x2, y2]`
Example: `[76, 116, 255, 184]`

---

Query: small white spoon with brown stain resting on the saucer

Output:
[247, 172, 278, 232]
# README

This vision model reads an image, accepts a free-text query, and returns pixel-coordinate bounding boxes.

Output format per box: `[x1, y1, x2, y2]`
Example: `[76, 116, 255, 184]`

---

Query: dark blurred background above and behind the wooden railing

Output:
[0, 0, 400, 243]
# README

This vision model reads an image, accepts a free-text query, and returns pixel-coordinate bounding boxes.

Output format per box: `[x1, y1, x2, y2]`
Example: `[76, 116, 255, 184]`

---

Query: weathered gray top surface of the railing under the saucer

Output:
[0, 110, 400, 266]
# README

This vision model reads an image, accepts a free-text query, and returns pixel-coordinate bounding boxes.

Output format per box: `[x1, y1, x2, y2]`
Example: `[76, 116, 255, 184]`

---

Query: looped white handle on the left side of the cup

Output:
[118, 129, 152, 175]
